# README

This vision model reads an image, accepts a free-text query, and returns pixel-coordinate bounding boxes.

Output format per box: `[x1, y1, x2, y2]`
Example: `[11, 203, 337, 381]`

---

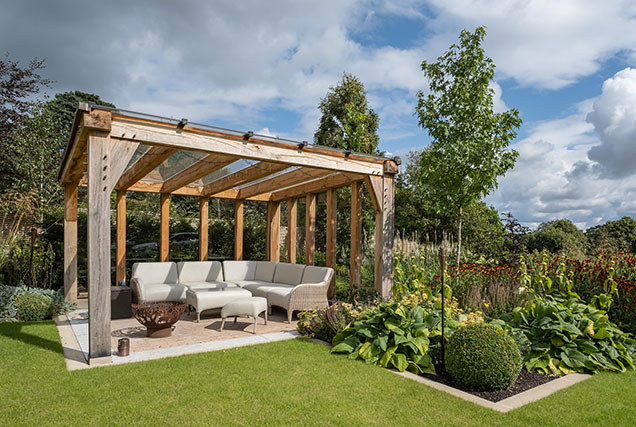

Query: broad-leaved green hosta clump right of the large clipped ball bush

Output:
[504, 263, 636, 375]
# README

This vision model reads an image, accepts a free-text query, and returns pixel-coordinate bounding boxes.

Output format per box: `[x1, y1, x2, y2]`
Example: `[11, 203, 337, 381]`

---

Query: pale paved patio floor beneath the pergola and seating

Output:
[56, 300, 299, 370]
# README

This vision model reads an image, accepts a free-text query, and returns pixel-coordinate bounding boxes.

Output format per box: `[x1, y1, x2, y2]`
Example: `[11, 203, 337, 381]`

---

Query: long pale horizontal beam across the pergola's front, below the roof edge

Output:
[111, 116, 384, 175]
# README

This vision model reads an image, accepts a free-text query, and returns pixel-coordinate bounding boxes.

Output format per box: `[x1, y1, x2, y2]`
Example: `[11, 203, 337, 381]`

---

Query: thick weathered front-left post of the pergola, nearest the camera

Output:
[87, 132, 114, 359]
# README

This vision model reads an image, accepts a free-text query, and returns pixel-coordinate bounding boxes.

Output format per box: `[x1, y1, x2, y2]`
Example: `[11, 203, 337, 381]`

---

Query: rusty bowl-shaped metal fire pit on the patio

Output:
[131, 301, 185, 338]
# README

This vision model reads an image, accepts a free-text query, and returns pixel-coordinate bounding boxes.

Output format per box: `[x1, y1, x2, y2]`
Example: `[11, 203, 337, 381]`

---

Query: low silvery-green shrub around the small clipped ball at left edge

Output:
[0, 285, 74, 322]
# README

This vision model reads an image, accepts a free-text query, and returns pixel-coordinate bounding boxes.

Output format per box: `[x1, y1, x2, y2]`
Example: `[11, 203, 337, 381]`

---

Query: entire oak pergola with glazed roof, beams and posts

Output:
[59, 103, 398, 359]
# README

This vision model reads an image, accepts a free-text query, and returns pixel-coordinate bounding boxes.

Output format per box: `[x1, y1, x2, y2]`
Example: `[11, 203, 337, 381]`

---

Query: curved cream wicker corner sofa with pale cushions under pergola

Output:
[131, 261, 334, 321]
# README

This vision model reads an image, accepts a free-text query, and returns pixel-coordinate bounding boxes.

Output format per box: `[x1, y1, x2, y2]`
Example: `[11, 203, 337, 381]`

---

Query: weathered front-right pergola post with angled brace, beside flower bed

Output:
[366, 174, 395, 298]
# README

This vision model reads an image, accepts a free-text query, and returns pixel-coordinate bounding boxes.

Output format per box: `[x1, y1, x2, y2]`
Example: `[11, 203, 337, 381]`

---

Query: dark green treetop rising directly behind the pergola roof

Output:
[314, 73, 379, 154]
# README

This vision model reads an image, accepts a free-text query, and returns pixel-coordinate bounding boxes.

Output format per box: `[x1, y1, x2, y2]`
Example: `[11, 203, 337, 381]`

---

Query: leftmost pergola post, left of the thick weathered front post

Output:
[64, 183, 77, 304]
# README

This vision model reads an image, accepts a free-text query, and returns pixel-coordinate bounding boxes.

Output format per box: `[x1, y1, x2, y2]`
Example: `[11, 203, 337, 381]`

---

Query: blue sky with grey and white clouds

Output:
[0, 0, 636, 228]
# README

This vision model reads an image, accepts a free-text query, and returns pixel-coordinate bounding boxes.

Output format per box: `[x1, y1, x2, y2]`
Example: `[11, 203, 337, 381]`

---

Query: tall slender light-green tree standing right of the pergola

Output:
[416, 27, 521, 263]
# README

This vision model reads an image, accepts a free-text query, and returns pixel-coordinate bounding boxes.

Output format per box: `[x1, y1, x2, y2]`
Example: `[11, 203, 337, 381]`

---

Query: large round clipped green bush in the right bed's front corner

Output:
[444, 323, 522, 390]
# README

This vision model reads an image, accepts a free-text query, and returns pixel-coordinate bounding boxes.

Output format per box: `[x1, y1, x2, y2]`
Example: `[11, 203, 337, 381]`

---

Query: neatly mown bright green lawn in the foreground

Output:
[0, 322, 636, 426]
